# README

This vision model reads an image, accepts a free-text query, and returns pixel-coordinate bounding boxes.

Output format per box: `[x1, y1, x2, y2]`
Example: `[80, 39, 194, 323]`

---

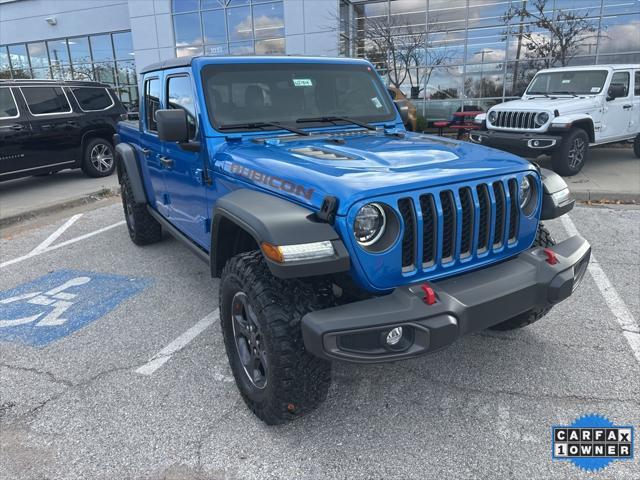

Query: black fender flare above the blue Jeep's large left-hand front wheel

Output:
[210, 189, 351, 278]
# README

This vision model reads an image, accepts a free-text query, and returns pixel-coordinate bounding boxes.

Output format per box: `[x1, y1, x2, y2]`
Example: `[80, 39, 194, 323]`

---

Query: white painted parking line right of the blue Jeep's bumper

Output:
[560, 215, 640, 363]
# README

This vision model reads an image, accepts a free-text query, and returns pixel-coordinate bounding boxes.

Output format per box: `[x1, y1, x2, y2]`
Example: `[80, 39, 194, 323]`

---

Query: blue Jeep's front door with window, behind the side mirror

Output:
[162, 70, 210, 248]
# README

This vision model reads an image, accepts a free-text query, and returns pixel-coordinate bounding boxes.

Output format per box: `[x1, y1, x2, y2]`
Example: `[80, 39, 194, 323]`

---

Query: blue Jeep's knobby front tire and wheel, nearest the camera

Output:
[219, 251, 333, 425]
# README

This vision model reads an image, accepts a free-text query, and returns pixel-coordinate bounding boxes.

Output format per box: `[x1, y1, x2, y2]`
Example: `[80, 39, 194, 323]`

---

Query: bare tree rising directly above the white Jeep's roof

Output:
[503, 0, 599, 68]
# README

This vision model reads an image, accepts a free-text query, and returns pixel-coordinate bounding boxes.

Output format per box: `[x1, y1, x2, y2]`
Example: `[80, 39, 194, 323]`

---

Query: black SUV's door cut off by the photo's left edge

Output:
[0, 87, 34, 180]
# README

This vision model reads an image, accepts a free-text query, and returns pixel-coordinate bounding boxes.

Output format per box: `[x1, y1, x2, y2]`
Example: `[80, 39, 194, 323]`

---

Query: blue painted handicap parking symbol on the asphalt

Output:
[0, 270, 150, 347]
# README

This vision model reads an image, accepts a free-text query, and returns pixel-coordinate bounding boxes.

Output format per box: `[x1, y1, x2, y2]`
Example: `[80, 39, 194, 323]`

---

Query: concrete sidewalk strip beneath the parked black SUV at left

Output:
[0, 170, 120, 227]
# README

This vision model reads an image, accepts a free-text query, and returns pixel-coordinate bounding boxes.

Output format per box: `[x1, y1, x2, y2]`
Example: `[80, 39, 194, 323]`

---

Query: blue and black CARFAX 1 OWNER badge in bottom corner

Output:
[551, 414, 634, 471]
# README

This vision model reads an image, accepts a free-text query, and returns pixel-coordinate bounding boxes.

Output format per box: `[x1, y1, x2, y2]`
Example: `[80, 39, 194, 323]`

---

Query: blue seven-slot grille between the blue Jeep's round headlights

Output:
[398, 178, 520, 272]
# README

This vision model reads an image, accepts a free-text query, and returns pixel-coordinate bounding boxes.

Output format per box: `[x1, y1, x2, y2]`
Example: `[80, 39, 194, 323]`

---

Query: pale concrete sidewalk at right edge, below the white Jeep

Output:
[538, 147, 640, 203]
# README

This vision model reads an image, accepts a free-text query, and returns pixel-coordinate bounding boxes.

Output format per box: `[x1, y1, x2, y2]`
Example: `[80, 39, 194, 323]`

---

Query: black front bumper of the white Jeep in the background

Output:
[469, 130, 562, 156]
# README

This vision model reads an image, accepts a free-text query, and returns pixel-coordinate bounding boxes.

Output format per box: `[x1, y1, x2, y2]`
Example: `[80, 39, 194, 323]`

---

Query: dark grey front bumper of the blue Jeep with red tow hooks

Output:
[302, 236, 591, 363]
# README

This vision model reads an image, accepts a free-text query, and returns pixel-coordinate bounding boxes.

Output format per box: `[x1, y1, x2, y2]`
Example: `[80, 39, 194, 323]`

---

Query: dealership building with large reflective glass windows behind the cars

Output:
[0, 0, 640, 120]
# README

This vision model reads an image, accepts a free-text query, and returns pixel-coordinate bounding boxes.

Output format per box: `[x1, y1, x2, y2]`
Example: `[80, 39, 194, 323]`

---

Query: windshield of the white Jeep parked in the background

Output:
[527, 70, 608, 95]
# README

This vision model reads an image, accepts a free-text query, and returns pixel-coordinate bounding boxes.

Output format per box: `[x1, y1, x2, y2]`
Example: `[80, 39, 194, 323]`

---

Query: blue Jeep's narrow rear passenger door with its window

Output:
[137, 77, 169, 218]
